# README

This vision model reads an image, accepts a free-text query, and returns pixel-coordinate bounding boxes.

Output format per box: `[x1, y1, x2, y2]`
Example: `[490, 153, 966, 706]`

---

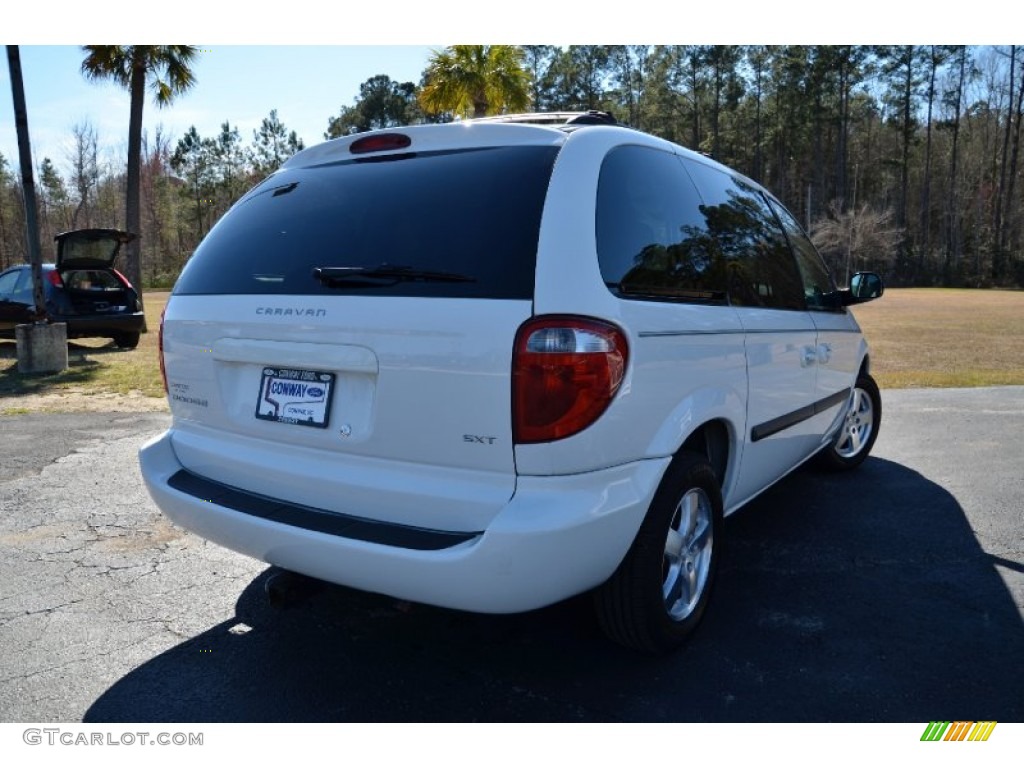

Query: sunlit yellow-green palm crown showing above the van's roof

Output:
[419, 45, 529, 118]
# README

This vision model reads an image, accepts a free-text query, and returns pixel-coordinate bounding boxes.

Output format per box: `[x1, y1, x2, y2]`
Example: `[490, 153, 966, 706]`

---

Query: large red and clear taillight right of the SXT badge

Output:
[512, 315, 629, 443]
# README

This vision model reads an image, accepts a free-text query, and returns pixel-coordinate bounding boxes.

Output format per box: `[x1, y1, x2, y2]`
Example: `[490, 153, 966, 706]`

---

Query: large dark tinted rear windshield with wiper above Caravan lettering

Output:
[174, 146, 558, 299]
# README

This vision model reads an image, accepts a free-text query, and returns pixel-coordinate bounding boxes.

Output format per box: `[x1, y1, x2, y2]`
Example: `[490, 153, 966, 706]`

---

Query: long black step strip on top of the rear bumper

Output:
[168, 469, 482, 551]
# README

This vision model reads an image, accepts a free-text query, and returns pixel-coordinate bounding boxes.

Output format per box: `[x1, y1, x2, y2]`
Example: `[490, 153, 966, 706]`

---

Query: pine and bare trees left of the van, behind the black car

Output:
[0, 111, 304, 288]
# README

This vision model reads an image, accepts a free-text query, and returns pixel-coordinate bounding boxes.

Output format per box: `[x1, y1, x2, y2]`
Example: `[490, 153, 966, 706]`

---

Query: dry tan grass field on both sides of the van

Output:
[0, 289, 1024, 416]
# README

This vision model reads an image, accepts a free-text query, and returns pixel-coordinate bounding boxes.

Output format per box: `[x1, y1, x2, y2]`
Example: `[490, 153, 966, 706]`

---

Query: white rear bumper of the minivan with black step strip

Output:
[139, 430, 670, 613]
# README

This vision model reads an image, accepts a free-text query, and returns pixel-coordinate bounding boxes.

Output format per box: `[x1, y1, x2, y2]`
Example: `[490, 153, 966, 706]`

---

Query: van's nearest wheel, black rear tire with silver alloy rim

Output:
[594, 453, 722, 653]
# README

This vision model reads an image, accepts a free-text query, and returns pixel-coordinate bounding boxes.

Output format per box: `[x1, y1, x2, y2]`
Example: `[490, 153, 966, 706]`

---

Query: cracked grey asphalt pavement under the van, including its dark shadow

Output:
[0, 387, 1024, 723]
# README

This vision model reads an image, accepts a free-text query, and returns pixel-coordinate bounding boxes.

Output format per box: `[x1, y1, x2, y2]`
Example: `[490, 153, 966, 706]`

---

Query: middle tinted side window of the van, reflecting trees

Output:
[682, 160, 805, 309]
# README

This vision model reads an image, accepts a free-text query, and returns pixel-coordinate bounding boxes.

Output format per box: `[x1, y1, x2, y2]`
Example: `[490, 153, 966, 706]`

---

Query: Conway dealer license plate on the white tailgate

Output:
[256, 368, 334, 429]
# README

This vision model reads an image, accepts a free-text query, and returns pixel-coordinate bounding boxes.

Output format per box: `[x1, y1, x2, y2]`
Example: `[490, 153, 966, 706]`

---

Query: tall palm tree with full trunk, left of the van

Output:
[82, 45, 199, 299]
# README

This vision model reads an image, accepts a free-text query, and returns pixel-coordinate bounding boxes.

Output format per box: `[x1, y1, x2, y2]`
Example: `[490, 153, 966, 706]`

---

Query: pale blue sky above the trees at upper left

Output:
[0, 45, 443, 173]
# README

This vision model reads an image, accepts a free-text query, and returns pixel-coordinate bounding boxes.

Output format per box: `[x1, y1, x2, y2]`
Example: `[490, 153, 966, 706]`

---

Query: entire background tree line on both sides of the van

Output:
[0, 45, 1024, 287]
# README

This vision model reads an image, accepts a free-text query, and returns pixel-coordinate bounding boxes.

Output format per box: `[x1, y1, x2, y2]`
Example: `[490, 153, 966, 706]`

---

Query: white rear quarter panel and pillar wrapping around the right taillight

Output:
[516, 127, 746, 475]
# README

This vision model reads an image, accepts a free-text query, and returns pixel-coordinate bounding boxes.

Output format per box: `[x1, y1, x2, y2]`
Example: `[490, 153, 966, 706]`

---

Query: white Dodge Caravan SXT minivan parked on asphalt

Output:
[140, 114, 883, 652]
